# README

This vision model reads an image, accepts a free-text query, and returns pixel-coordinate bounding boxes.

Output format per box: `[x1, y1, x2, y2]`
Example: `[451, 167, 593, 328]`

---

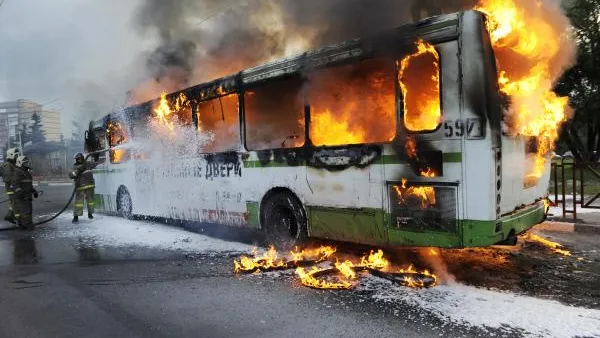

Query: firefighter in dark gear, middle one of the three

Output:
[13, 155, 38, 230]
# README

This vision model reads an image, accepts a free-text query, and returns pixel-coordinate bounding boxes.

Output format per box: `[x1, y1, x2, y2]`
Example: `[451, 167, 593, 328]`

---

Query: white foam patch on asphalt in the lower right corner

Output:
[361, 277, 600, 337]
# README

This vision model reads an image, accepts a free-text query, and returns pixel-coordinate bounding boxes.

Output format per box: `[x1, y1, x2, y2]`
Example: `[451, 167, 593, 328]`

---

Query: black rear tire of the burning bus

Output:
[262, 192, 308, 249]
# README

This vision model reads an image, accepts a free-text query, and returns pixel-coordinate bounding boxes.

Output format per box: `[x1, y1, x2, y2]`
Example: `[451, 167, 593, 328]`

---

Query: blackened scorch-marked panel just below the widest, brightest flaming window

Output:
[308, 145, 382, 171]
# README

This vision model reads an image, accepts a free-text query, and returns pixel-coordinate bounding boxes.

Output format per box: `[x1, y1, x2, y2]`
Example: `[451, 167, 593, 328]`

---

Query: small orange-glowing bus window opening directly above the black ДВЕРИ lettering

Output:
[196, 94, 240, 153]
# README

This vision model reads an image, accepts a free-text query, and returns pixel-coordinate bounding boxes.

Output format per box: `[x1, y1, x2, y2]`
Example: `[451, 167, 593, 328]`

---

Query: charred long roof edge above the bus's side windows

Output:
[95, 12, 464, 128]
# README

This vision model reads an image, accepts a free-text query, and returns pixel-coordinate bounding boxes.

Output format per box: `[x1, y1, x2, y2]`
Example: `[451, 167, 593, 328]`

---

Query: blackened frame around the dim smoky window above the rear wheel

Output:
[238, 73, 314, 152]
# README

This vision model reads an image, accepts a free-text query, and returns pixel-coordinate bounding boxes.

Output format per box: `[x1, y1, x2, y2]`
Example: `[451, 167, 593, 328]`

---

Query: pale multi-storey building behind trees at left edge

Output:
[0, 100, 61, 148]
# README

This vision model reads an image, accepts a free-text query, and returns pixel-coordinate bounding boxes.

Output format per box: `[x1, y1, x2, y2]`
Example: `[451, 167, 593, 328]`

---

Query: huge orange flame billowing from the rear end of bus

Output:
[475, 0, 572, 181]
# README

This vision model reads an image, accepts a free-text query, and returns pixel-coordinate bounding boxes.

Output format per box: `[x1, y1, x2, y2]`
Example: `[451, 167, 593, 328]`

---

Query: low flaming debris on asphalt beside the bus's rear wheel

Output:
[233, 246, 438, 289]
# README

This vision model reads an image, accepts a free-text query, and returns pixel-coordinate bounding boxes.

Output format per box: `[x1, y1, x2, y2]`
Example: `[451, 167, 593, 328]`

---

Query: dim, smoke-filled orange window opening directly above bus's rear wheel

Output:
[244, 78, 305, 150]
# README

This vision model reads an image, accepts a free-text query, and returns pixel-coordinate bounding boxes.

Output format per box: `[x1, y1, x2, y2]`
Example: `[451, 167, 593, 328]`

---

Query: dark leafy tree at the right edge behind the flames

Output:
[556, 0, 600, 162]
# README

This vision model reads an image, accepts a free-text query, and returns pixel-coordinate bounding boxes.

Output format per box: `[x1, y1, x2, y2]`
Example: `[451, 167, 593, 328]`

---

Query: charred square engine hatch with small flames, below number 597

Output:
[388, 182, 458, 233]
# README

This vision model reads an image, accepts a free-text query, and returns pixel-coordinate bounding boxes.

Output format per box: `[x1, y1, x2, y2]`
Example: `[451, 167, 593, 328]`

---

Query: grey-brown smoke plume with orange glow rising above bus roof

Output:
[129, 0, 474, 103]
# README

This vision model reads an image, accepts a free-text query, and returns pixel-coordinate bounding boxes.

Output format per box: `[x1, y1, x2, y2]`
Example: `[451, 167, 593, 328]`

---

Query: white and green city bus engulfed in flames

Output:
[85, 11, 550, 247]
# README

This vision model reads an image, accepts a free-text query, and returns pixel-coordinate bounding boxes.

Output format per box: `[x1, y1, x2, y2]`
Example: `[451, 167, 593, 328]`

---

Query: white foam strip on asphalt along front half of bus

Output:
[40, 214, 252, 253]
